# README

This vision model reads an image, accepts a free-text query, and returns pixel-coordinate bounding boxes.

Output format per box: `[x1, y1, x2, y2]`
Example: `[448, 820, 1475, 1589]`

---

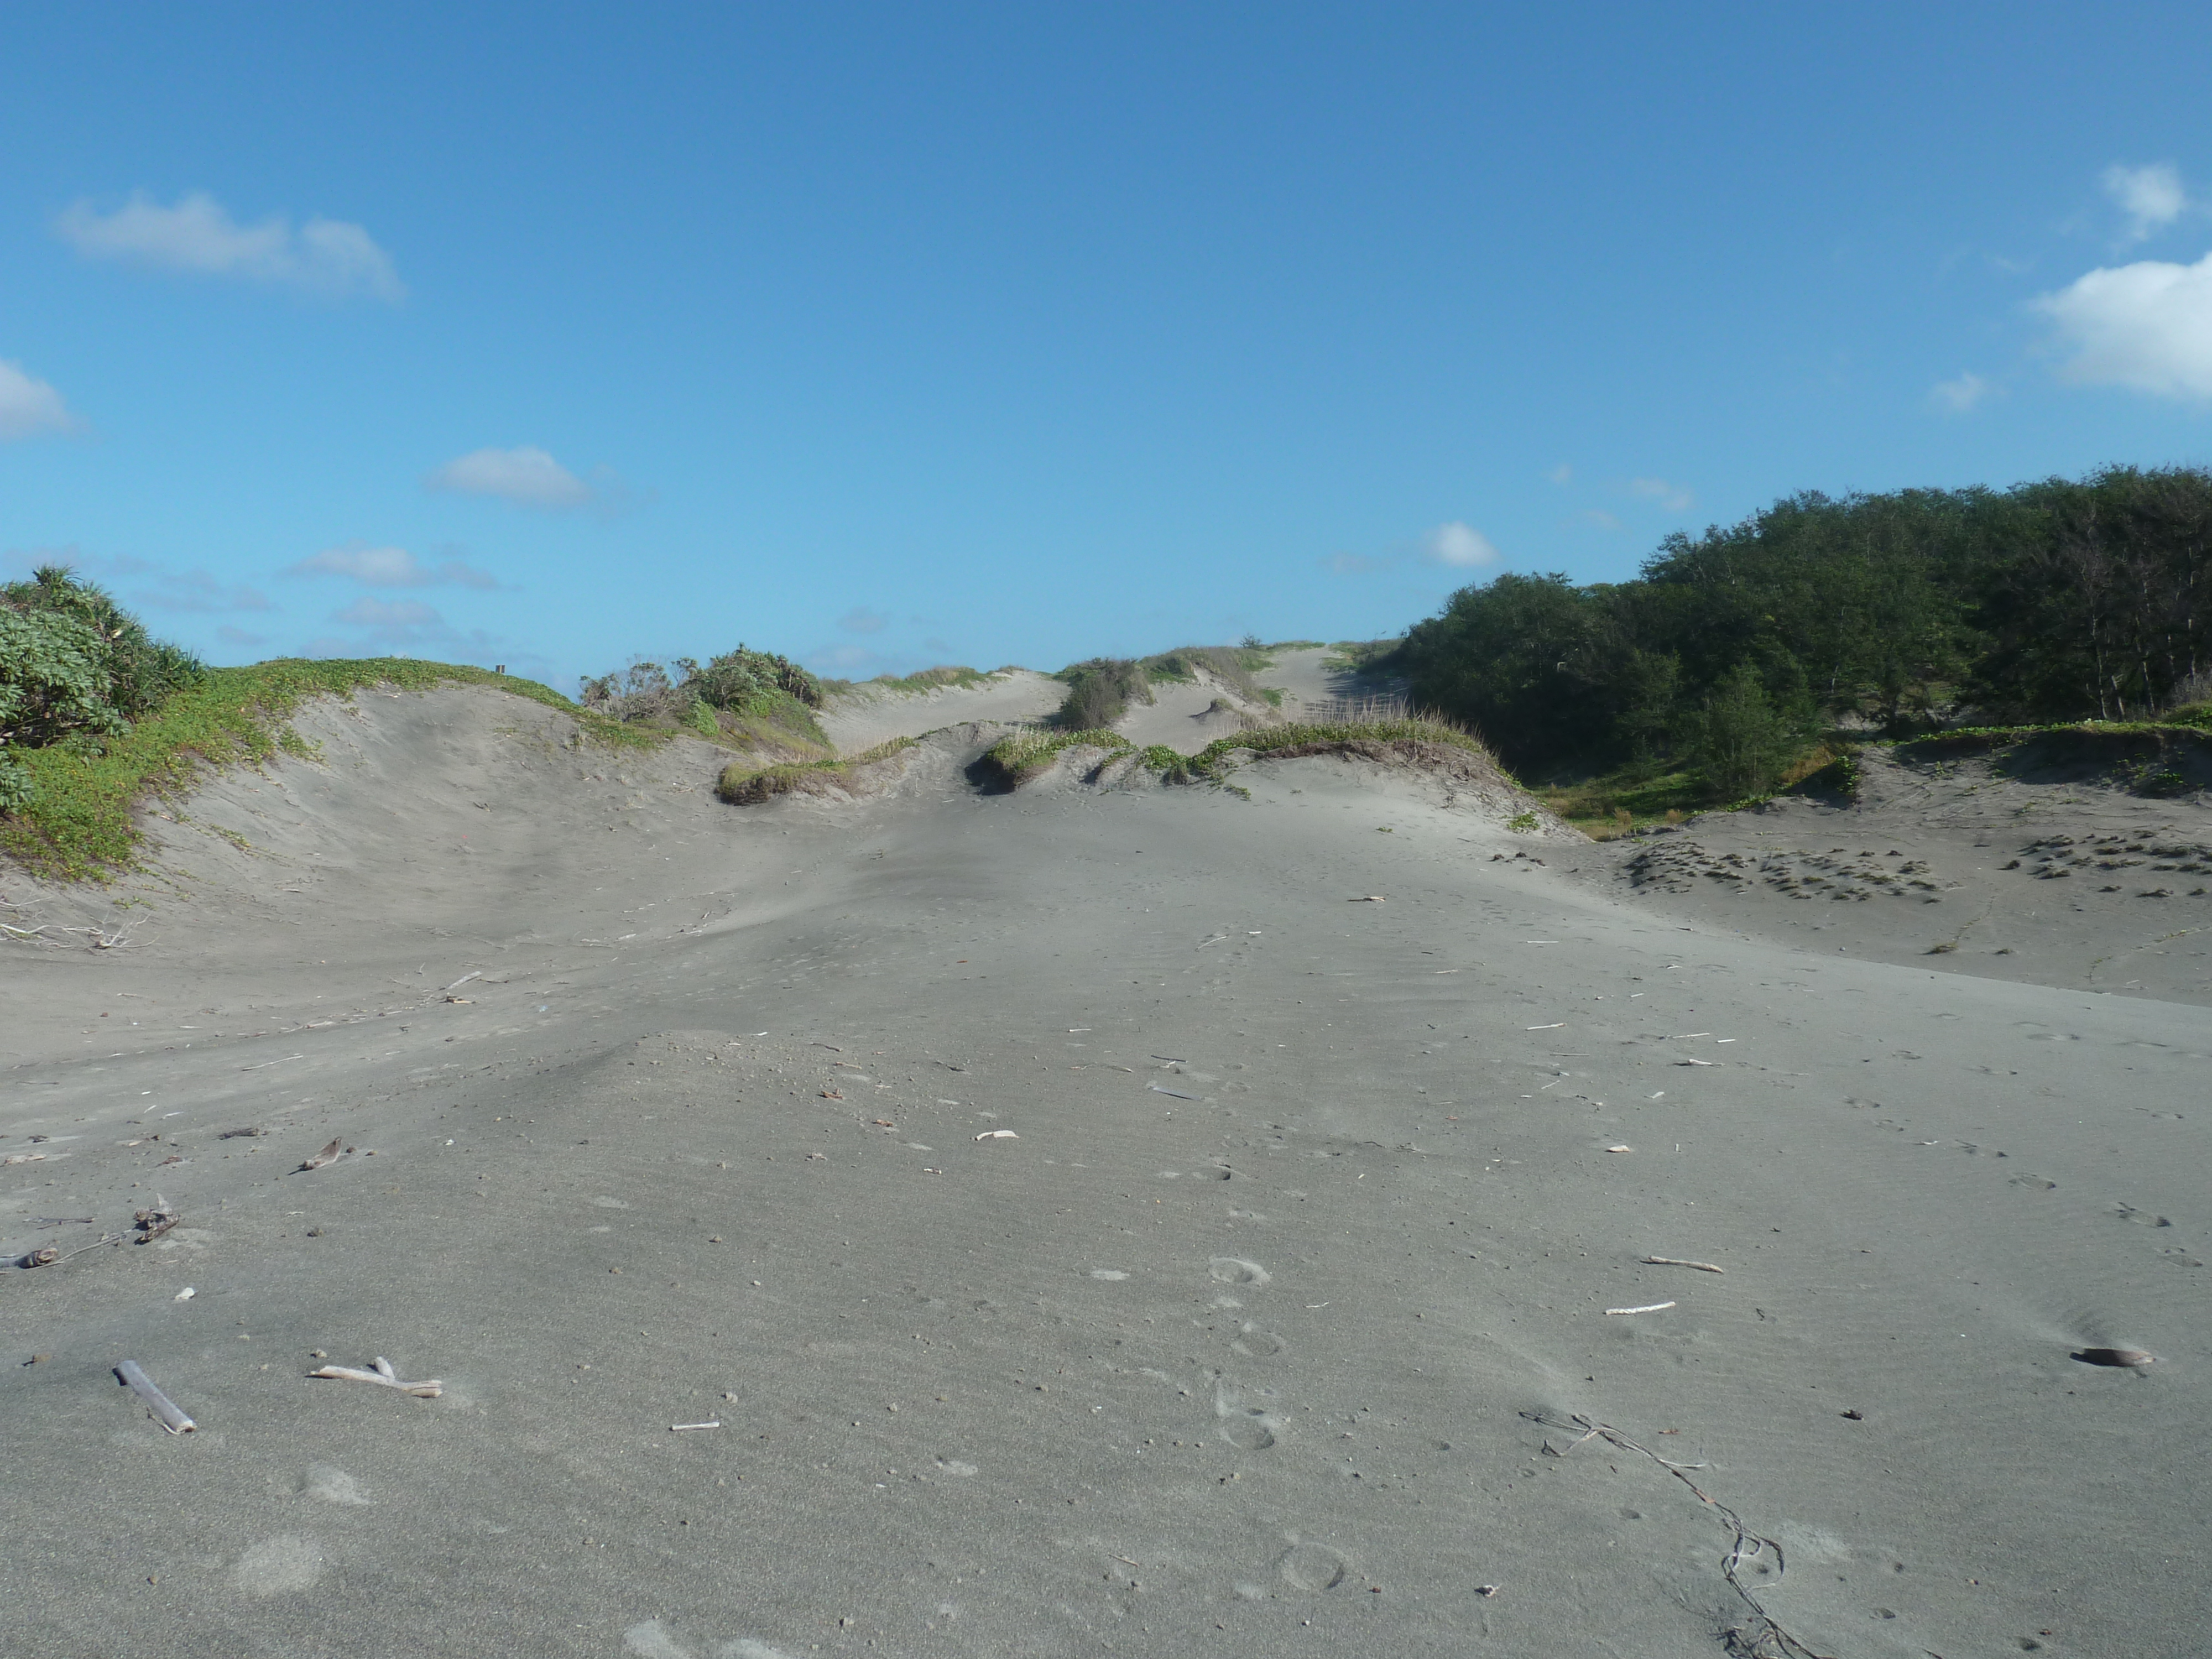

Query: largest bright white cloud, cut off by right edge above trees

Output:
[2031, 254, 2212, 398]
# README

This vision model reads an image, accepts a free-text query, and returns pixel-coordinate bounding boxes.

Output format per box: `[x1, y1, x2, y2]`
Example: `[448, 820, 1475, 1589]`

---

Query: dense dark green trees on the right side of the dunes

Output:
[1376, 467, 2212, 801]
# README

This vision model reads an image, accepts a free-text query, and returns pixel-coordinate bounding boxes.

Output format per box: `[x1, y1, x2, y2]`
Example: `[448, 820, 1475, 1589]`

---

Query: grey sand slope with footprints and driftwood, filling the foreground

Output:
[0, 690, 2212, 1659]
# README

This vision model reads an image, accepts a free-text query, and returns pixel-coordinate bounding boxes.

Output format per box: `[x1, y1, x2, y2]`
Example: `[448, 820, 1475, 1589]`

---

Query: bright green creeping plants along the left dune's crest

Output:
[0, 657, 633, 880]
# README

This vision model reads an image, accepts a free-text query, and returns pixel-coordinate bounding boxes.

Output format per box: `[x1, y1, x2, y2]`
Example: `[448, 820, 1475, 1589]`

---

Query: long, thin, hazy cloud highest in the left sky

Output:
[53, 190, 407, 303]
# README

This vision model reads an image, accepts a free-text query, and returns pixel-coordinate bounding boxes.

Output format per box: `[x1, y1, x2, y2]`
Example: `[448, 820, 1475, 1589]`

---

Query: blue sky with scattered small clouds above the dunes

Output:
[0, 0, 2212, 690]
